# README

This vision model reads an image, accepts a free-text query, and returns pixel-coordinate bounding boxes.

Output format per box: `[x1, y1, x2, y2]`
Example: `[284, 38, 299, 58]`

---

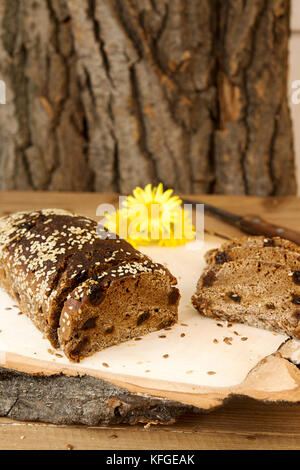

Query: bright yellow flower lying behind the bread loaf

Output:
[105, 183, 195, 247]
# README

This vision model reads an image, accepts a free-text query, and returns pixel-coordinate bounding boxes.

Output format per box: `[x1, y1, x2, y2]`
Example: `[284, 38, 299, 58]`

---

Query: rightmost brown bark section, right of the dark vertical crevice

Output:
[215, 0, 295, 196]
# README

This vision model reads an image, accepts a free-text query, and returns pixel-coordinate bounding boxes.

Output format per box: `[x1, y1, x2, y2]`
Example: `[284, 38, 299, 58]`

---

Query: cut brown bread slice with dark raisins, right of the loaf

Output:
[192, 237, 300, 338]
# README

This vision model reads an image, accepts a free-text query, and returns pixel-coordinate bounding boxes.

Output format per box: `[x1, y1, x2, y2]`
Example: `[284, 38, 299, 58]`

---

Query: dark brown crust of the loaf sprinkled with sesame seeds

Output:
[0, 209, 177, 360]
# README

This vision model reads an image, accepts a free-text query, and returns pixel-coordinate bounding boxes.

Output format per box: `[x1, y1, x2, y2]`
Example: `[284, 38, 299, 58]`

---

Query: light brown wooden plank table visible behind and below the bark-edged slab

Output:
[0, 191, 300, 450]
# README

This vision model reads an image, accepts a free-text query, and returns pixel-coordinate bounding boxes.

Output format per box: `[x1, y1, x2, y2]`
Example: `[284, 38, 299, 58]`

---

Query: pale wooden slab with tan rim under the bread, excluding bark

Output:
[0, 238, 300, 409]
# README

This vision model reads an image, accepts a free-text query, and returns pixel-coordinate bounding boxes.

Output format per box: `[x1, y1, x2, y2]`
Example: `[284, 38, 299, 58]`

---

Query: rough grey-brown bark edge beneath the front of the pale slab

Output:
[0, 367, 195, 426]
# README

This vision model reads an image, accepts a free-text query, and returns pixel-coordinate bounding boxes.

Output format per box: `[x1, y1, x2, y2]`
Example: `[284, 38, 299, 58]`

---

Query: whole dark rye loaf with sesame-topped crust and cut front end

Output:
[0, 209, 180, 361]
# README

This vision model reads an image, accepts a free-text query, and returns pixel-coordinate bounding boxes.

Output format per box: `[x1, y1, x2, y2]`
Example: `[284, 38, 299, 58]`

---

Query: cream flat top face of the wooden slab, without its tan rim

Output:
[0, 242, 286, 391]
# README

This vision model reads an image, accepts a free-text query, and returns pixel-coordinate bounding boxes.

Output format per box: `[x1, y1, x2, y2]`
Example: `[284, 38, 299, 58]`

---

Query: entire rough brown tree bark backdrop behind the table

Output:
[0, 0, 296, 195]
